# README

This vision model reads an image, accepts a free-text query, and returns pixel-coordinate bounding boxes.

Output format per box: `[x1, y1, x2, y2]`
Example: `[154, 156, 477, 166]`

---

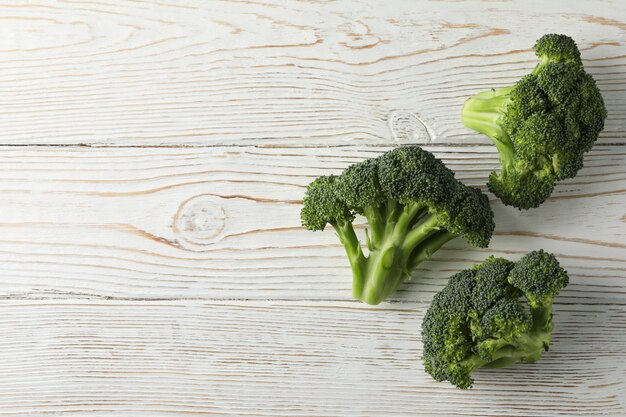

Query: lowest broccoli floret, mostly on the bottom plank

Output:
[422, 250, 568, 388]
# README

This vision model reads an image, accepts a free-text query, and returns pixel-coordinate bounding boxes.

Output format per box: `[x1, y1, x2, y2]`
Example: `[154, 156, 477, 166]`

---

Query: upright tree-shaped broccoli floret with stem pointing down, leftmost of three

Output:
[301, 146, 495, 304]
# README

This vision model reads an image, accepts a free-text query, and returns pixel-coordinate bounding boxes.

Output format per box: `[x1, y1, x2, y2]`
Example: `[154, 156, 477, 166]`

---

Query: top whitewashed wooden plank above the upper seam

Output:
[0, 0, 626, 146]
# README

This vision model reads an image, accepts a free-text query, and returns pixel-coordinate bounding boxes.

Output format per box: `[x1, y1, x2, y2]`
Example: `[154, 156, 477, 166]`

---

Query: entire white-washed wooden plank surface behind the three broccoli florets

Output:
[0, 0, 626, 417]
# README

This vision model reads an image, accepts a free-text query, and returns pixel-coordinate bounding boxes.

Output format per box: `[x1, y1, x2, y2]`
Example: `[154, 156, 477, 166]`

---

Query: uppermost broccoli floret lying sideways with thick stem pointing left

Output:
[461, 34, 607, 210]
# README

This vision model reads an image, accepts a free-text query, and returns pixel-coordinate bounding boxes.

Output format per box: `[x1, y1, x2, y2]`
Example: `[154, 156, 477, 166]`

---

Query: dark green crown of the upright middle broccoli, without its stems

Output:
[301, 146, 495, 247]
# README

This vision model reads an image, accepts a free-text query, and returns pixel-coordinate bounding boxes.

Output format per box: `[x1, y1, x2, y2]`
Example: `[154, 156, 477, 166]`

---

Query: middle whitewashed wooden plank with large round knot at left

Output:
[0, 146, 626, 305]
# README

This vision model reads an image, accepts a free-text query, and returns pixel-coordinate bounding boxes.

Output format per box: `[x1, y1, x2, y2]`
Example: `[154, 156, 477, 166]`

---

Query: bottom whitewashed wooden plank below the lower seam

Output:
[0, 301, 626, 417]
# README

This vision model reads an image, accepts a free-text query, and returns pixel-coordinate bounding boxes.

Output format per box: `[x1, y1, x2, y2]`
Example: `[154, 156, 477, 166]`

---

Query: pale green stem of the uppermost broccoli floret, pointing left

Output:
[461, 87, 515, 171]
